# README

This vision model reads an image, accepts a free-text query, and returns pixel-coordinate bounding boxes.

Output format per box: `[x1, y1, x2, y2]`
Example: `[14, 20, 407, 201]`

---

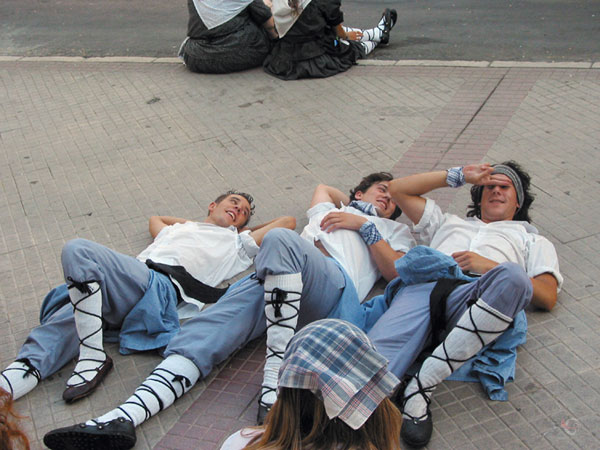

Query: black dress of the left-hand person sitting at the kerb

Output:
[182, 0, 271, 73]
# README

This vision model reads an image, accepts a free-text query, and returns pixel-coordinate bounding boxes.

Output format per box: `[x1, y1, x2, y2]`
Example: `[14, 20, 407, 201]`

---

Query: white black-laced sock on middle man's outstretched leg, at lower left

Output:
[86, 355, 200, 427]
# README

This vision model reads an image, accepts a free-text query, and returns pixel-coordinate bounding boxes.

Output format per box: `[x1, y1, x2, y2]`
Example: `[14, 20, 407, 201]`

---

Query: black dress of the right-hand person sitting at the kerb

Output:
[263, 0, 364, 80]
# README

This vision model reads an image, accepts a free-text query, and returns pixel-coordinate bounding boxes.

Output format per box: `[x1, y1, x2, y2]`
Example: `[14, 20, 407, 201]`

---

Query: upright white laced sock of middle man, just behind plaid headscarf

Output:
[260, 273, 302, 406]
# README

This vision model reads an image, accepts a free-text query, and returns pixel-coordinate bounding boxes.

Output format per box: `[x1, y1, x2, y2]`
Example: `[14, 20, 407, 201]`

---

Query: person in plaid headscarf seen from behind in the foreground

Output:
[221, 319, 402, 450]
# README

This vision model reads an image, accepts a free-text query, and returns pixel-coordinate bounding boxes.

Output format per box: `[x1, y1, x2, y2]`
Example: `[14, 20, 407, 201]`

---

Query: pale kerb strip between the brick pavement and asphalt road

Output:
[0, 55, 600, 69]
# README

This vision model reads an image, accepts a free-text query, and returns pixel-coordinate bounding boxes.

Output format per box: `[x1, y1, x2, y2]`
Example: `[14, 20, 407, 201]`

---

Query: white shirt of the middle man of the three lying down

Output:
[301, 202, 415, 302]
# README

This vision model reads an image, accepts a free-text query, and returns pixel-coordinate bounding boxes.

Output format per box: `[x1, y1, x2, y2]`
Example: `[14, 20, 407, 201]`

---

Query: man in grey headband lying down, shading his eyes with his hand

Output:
[368, 161, 563, 447]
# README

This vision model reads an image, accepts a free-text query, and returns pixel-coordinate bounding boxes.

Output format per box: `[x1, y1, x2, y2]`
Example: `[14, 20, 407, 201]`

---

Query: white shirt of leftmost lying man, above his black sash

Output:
[137, 222, 258, 319]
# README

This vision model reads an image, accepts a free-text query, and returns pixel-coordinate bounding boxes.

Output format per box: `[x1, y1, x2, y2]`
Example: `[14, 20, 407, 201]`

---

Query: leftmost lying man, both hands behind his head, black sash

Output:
[0, 191, 296, 402]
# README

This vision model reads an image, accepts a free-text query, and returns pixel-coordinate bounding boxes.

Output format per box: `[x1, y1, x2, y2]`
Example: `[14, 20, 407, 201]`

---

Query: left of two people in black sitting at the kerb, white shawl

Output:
[179, 0, 277, 73]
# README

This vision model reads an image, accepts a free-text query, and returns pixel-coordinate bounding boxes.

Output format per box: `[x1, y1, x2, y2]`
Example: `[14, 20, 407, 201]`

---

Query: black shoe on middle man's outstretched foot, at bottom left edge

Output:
[44, 417, 136, 450]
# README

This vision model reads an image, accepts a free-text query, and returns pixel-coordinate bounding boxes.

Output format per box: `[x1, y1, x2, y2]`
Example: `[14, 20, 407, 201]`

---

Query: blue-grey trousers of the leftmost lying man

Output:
[17, 239, 150, 379]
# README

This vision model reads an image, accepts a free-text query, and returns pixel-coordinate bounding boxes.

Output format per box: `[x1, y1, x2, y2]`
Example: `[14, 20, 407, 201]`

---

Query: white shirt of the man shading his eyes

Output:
[414, 199, 563, 290]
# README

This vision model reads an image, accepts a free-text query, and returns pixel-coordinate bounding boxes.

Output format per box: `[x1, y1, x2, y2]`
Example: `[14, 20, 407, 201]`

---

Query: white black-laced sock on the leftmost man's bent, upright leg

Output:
[67, 281, 106, 386]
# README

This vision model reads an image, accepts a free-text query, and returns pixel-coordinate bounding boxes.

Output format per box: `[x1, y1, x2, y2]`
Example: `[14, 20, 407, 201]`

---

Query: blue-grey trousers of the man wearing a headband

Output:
[368, 263, 533, 378]
